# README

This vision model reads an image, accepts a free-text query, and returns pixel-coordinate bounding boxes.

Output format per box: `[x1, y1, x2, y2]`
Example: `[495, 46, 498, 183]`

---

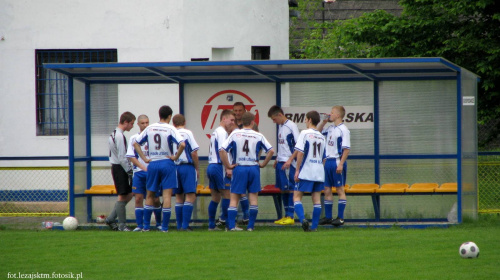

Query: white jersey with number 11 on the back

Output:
[295, 128, 325, 182]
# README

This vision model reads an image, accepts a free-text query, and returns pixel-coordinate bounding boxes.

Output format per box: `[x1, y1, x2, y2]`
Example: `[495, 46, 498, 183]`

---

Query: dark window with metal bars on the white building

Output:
[35, 49, 118, 136]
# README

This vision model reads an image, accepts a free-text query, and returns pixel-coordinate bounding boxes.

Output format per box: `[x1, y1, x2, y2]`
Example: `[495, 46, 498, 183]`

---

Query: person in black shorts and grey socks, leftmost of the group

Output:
[105, 112, 135, 231]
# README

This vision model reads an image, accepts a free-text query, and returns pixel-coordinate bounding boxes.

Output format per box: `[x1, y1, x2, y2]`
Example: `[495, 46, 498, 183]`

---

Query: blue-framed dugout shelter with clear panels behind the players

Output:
[44, 58, 478, 225]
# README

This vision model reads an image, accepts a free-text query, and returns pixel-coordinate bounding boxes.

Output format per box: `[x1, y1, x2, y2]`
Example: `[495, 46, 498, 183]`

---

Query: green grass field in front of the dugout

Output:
[0, 215, 500, 279]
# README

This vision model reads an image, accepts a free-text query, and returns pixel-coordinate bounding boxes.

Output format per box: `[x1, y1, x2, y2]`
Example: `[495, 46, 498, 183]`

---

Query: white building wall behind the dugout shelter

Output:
[0, 0, 288, 166]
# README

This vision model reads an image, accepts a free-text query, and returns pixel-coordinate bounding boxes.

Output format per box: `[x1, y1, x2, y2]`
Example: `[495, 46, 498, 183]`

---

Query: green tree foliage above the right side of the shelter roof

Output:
[301, 0, 500, 144]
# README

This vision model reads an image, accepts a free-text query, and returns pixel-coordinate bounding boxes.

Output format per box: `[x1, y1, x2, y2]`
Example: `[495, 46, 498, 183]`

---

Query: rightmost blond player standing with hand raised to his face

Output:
[318, 106, 351, 226]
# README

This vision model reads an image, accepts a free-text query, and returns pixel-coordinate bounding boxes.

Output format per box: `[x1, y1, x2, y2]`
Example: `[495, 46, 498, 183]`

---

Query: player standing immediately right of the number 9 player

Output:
[172, 114, 200, 231]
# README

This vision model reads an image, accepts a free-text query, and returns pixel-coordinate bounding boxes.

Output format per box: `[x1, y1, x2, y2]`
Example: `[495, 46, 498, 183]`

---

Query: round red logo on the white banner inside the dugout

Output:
[201, 89, 259, 138]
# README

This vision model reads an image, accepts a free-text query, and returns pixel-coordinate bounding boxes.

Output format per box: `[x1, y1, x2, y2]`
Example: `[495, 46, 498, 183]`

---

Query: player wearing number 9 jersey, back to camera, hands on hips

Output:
[134, 105, 185, 232]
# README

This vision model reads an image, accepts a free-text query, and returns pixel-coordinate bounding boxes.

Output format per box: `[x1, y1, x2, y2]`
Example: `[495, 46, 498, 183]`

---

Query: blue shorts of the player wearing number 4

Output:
[231, 165, 260, 194]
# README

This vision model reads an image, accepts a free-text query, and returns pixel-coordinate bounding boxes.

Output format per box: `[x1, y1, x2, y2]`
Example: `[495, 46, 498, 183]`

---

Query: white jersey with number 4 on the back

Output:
[222, 128, 273, 166]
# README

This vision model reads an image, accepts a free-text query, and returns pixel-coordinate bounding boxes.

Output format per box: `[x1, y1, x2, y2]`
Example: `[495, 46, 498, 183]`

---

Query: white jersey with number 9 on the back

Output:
[136, 122, 184, 161]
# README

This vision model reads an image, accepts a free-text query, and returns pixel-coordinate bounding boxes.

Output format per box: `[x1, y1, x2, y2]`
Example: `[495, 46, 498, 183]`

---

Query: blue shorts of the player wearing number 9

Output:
[146, 159, 177, 192]
